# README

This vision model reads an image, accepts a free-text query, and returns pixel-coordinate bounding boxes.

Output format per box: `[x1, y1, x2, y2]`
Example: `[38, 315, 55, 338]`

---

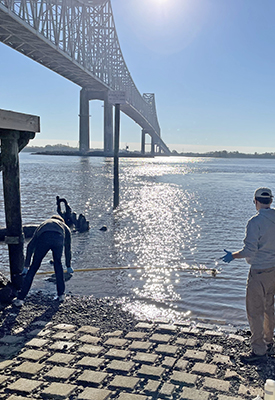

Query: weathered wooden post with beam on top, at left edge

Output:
[0, 110, 40, 290]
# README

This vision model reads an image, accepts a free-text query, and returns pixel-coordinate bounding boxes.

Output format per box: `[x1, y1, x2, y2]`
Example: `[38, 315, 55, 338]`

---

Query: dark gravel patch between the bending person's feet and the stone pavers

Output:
[0, 291, 137, 337]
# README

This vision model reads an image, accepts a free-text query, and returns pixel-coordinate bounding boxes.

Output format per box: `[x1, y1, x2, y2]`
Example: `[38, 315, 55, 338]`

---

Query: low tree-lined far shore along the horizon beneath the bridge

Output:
[22, 145, 275, 159]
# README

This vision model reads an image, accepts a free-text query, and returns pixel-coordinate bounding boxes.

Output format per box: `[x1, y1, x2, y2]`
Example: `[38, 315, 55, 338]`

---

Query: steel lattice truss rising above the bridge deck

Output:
[0, 0, 160, 136]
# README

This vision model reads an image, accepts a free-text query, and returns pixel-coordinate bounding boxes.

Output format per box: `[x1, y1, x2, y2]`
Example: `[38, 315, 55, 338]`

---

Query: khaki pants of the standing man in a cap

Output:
[246, 267, 275, 355]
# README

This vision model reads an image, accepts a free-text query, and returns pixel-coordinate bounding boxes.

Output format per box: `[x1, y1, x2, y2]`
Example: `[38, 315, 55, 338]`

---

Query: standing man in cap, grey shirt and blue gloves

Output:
[222, 188, 275, 363]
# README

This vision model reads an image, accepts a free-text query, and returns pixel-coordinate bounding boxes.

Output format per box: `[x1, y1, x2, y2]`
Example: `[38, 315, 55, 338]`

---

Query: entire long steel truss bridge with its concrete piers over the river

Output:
[0, 0, 170, 155]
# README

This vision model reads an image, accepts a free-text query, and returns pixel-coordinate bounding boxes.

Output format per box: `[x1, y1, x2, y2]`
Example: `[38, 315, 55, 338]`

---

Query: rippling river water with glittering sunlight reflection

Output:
[0, 153, 275, 327]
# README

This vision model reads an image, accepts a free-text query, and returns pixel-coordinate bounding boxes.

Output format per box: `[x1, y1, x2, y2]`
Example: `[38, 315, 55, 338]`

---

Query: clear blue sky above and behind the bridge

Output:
[0, 0, 275, 152]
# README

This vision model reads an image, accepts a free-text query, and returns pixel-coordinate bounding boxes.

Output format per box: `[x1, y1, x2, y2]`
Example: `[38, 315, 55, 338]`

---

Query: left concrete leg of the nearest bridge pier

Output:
[79, 88, 90, 152]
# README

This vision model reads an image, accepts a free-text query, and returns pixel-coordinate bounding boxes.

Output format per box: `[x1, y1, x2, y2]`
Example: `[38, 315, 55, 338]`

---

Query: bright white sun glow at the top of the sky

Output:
[122, 0, 207, 55]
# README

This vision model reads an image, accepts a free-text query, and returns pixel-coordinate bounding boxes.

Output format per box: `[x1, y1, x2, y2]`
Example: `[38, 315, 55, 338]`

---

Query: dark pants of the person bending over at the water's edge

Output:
[18, 232, 65, 300]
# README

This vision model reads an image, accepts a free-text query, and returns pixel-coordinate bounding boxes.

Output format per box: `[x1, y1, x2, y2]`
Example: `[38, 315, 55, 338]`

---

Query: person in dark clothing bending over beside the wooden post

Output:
[13, 215, 73, 307]
